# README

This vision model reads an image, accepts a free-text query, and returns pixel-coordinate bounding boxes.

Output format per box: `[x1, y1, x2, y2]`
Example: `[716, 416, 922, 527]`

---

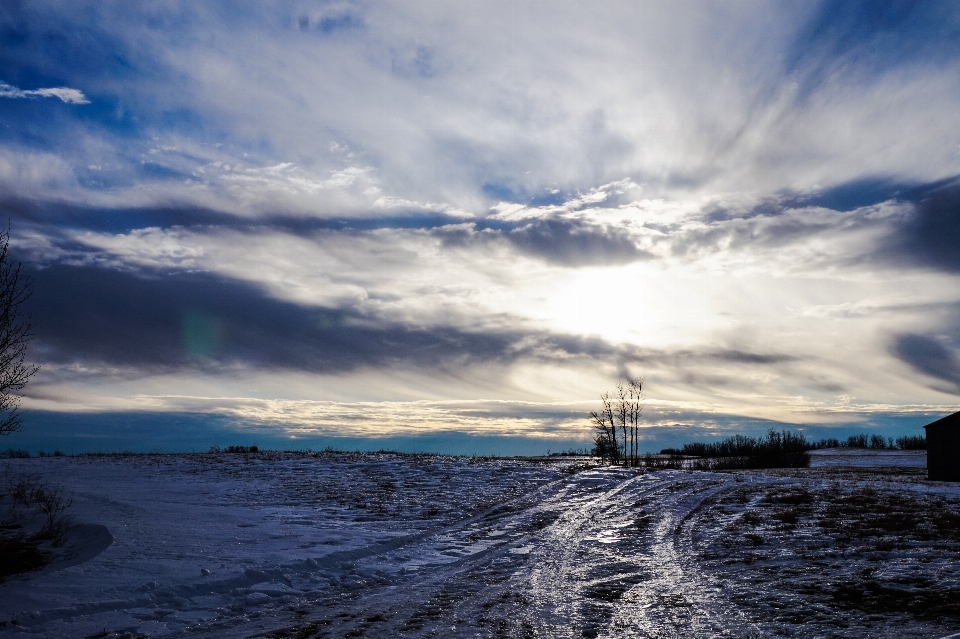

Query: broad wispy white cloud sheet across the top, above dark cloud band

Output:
[0, 2, 960, 215]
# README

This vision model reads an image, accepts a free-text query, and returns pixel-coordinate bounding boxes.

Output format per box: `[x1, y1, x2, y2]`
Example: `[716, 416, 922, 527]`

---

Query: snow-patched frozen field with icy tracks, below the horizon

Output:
[0, 451, 960, 638]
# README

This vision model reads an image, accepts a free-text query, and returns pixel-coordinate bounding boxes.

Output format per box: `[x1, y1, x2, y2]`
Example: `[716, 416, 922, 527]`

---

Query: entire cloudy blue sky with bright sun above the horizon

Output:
[0, 0, 960, 452]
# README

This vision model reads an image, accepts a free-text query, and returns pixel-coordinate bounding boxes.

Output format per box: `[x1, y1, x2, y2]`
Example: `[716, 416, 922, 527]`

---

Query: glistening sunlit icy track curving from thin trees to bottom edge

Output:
[506, 471, 750, 638]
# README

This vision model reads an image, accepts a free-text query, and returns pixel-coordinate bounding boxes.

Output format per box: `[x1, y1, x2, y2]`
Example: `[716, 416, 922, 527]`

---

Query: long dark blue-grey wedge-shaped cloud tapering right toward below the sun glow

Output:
[28, 266, 632, 372]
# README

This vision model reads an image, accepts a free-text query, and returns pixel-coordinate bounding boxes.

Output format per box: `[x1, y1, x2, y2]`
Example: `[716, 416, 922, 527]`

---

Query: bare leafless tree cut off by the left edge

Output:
[0, 226, 40, 435]
